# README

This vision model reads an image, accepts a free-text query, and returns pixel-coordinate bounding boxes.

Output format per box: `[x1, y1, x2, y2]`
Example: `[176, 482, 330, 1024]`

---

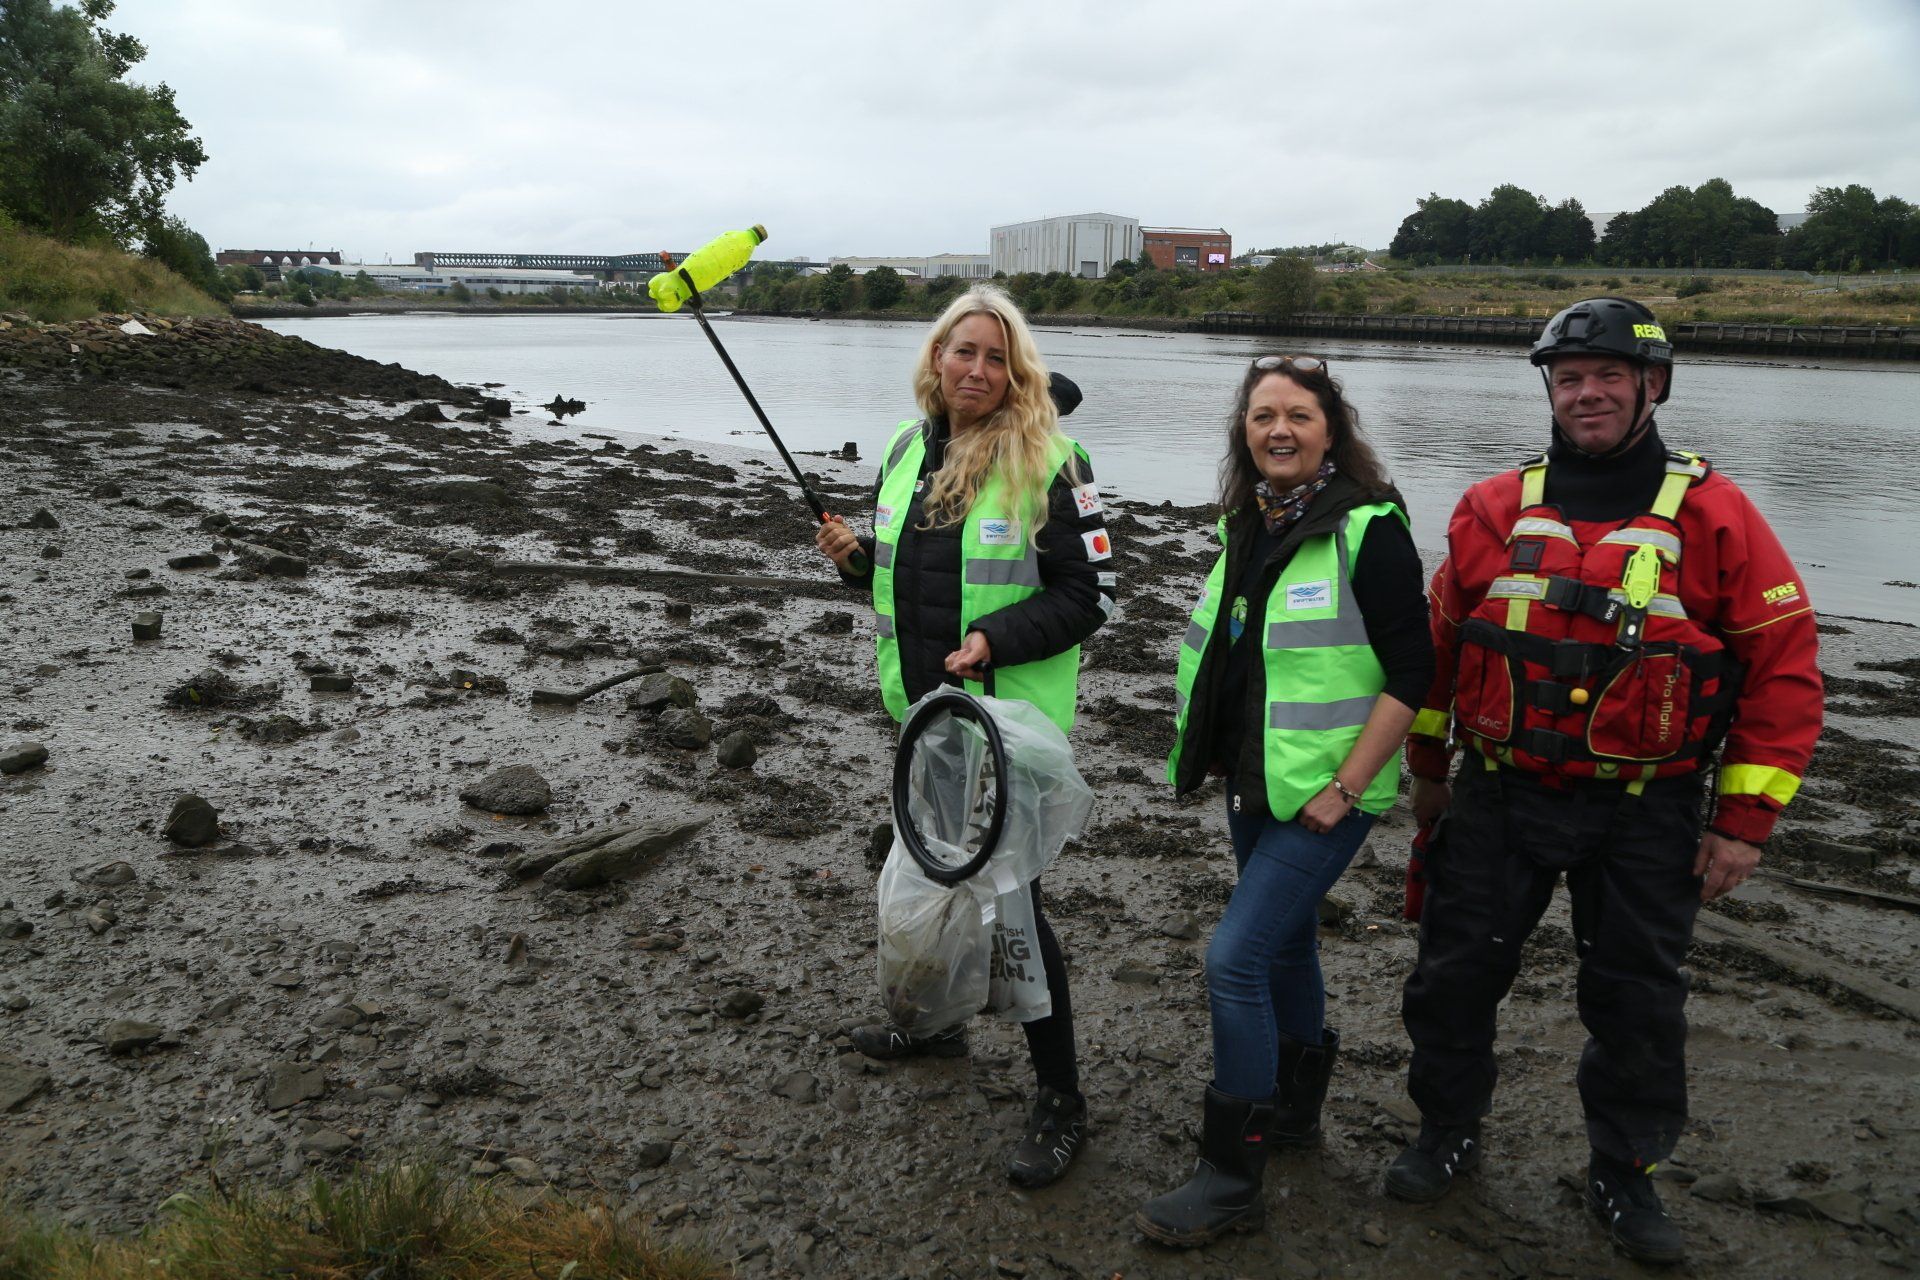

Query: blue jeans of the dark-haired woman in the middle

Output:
[1206, 791, 1373, 1098]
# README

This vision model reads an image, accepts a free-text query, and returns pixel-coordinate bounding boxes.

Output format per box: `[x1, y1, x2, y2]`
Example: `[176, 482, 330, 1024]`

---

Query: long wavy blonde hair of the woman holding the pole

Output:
[914, 284, 1079, 541]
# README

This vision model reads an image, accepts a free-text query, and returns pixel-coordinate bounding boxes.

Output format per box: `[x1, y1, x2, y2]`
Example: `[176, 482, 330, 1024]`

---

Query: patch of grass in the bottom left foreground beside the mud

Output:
[0, 1163, 730, 1280]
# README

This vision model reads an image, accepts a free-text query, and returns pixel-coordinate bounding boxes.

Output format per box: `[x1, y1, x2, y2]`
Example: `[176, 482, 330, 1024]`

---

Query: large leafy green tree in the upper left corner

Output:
[0, 0, 207, 242]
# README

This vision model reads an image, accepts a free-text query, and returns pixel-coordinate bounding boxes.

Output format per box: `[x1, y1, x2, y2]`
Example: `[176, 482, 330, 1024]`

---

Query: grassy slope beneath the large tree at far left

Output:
[0, 217, 227, 322]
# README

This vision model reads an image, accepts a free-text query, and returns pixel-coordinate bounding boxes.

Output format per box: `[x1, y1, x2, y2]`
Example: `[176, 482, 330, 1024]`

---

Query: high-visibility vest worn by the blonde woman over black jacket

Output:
[874, 418, 1087, 733]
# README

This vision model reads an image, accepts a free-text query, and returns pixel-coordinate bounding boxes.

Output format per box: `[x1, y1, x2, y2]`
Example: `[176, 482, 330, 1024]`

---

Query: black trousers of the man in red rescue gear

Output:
[1402, 752, 1703, 1163]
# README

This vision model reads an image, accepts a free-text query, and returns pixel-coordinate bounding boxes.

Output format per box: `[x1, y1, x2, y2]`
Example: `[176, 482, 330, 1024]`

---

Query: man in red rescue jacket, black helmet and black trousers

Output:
[1386, 297, 1822, 1263]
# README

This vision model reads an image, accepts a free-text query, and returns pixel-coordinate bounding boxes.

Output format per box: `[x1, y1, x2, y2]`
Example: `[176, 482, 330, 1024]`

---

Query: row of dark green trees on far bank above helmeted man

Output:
[1388, 178, 1920, 271]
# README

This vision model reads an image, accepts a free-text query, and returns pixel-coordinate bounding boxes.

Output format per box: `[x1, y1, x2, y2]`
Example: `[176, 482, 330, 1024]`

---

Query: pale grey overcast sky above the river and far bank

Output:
[108, 0, 1920, 261]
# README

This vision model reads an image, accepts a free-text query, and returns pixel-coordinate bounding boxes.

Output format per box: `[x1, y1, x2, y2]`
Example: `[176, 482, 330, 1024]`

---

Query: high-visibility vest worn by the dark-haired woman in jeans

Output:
[1167, 503, 1407, 821]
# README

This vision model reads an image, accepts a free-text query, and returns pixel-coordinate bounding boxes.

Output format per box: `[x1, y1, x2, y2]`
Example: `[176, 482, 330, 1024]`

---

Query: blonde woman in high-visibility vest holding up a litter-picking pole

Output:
[816, 284, 1116, 1188]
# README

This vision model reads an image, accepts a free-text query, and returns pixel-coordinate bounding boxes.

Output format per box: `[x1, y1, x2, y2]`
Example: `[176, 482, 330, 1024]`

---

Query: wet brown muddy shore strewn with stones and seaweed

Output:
[0, 312, 1920, 1278]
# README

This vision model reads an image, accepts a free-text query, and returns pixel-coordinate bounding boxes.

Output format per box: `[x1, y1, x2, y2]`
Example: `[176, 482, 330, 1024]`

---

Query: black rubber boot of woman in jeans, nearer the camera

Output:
[1133, 1086, 1273, 1249]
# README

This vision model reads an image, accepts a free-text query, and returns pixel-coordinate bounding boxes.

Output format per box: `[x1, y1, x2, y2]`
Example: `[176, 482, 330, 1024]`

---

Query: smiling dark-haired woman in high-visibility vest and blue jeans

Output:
[1135, 355, 1434, 1245]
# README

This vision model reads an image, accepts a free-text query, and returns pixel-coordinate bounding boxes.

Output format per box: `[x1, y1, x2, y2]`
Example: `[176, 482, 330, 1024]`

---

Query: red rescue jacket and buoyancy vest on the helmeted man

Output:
[1407, 453, 1822, 844]
